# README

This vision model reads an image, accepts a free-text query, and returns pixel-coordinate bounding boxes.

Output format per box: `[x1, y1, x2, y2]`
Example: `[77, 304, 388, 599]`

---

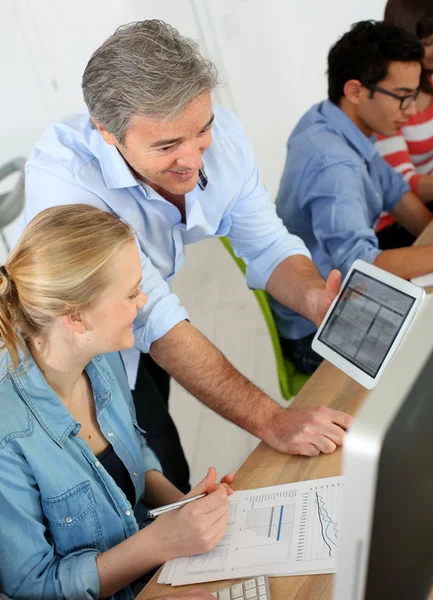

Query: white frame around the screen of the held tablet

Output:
[311, 259, 425, 390]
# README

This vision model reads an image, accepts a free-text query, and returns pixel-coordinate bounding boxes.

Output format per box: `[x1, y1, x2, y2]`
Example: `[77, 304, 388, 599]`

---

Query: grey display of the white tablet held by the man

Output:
[318, 269, 415, 377]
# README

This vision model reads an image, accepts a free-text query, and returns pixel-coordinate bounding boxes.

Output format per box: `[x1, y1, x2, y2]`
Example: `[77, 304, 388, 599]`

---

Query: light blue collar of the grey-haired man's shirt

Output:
[91, 122, 208, 191]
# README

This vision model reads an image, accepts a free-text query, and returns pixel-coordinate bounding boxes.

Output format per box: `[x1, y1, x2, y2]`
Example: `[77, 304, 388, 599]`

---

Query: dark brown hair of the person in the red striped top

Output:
[384, 0, 433, 94]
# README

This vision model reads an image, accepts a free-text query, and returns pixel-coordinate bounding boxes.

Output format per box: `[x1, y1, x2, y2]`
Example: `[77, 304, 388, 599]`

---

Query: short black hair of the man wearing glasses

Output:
[328, 21, 424, 104]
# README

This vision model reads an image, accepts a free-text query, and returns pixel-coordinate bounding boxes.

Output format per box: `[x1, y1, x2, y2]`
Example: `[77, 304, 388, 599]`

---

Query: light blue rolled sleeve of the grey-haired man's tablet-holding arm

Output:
[228, 135, 311, 289]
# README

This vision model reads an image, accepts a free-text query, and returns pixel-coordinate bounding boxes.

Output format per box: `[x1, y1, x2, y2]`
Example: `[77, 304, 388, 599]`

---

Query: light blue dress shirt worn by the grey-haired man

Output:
[19, 106, 310, 360]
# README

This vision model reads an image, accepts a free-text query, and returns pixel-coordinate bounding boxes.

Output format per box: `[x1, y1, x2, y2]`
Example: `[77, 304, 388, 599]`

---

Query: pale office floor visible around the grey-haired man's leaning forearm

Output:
[170, 239, 287, 484]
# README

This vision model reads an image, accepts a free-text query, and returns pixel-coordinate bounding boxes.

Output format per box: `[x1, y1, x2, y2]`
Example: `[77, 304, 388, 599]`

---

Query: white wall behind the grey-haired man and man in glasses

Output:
[0, 0, 385, 255]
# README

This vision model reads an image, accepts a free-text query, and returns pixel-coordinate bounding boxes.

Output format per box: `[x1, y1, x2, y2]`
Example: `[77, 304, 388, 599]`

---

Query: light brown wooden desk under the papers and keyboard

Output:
[138, 221, 433, 600]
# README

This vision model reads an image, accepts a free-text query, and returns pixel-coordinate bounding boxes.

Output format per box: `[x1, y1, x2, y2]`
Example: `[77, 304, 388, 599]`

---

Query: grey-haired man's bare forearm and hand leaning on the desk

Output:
[152, 324, 351, 460]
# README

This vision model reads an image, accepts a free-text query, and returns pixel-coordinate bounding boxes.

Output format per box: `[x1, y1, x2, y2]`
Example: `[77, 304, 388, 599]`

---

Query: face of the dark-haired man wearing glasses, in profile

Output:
[357, 62, 421, 136]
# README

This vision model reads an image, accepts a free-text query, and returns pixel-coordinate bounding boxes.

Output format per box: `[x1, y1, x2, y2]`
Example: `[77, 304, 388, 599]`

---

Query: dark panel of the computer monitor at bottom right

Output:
[364, 354, 433, 600]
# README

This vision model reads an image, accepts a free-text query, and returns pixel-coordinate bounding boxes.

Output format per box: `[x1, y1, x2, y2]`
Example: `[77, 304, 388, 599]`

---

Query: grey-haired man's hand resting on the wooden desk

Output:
[262, 406, 352, 456]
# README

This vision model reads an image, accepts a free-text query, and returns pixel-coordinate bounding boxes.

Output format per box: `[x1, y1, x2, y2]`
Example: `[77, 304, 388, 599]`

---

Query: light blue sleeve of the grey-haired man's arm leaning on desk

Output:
[24, 165, 189, 352]
